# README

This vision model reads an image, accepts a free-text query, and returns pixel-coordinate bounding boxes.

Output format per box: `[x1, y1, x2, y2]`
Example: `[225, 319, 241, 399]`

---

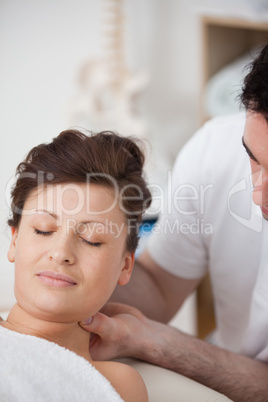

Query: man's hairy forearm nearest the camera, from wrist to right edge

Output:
[136, 320, 268, 402]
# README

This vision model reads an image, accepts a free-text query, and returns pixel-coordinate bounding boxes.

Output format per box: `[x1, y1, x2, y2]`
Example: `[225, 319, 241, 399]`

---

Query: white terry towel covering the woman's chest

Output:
[0, 326, 123, 402]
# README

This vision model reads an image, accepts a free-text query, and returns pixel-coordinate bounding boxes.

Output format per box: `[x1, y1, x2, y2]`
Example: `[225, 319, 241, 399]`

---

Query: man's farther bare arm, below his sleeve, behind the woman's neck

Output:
[111, 250, 200, 323]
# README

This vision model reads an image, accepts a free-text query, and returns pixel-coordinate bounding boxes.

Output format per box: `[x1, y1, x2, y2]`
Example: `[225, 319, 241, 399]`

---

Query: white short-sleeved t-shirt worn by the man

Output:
[147, 113, 268, 361]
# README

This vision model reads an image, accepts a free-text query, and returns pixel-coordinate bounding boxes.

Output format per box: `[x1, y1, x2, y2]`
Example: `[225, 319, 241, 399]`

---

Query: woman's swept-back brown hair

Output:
[8, 130, 151, 251]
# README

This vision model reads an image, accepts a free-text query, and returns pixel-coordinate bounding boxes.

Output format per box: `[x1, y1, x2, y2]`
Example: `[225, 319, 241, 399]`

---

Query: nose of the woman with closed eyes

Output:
[48, 236, 75, 265]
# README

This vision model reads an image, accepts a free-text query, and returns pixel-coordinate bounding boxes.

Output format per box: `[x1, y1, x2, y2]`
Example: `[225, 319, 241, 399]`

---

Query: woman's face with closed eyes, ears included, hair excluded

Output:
[8, 184, 134, 322]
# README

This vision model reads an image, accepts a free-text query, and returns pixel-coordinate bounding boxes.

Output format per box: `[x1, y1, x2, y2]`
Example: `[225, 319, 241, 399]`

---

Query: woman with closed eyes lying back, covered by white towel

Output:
[0, 130, 151, 402]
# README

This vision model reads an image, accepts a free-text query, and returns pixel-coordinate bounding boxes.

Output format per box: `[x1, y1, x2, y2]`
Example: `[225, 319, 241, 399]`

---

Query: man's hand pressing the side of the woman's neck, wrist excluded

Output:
[80, 303, 155, 360]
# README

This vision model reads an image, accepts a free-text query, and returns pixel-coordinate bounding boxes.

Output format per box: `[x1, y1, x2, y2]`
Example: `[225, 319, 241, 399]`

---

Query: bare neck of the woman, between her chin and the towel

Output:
[1, 304, 92, 361]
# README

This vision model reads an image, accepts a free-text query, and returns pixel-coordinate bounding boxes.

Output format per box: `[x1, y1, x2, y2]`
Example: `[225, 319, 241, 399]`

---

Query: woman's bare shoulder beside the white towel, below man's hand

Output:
[92, 361, 149, 402]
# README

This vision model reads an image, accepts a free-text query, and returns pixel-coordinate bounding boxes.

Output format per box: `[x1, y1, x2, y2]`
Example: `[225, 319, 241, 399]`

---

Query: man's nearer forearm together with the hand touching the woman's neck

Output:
[81, 303, 268, 402]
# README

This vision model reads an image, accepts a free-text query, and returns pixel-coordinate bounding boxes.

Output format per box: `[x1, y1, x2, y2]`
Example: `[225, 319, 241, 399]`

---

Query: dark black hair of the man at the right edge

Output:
[240, 45, 268, 116]
